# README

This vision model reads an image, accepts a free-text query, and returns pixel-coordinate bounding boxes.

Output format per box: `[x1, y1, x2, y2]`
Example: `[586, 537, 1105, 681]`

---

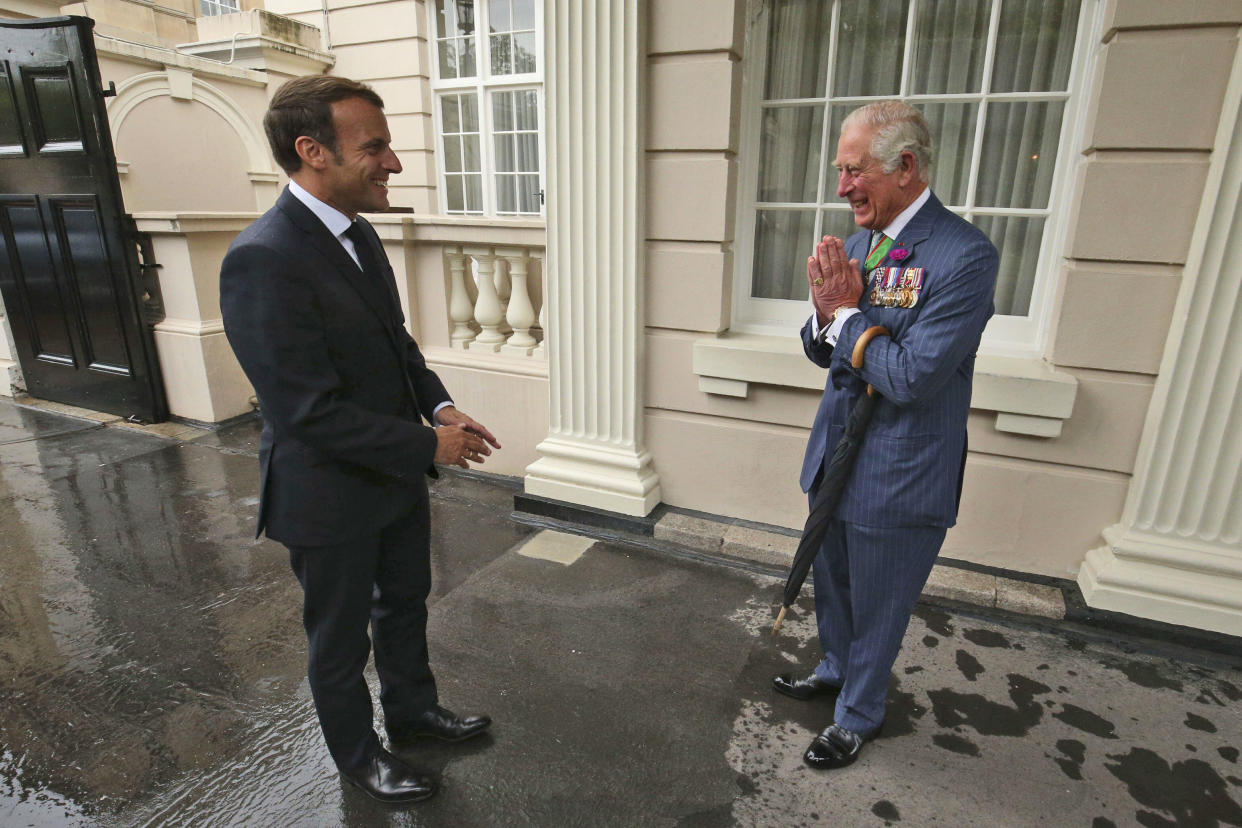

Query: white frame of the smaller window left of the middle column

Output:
[426, 0, 548, 218]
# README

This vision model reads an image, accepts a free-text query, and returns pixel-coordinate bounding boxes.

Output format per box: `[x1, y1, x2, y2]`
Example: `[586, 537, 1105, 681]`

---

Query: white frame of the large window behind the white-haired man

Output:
[732, 0, 1103, 356]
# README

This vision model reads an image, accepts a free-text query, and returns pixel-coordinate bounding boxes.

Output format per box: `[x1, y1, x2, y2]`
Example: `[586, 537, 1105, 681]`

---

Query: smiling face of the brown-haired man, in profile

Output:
[315, 98, 401, 218]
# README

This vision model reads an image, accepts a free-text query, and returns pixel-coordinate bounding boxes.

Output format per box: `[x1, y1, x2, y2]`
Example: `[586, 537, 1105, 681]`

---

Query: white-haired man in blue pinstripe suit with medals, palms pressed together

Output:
[773, 101, 999, 768]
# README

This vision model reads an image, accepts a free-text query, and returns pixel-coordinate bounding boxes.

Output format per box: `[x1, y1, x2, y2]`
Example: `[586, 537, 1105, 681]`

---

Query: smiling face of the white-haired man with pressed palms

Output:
[832, 124, 923, 230]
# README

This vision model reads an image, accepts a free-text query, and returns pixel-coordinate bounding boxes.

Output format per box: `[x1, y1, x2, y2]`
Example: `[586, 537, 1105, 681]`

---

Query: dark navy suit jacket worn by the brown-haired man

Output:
[220, 190, 448, 546]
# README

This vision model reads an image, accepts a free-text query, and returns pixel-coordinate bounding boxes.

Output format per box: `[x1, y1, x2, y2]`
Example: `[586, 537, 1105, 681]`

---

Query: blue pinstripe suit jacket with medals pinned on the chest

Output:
[801, 195, 999, 526]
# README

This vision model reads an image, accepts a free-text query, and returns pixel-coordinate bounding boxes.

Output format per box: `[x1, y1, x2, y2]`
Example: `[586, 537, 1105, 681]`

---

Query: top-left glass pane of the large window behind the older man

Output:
[764, 0, 832, 101]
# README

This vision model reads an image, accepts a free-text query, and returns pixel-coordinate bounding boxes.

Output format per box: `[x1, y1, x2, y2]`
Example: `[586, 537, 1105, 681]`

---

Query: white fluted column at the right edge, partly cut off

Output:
[1078, 76, 1242, 636]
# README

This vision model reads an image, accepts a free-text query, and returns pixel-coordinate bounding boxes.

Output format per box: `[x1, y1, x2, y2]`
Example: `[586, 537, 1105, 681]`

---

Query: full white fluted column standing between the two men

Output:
[525, 0, 660, 515]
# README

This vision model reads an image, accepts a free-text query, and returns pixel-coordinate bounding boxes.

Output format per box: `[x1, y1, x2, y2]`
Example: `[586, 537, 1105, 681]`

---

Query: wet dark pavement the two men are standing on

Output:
[0, 401, 1242, 828]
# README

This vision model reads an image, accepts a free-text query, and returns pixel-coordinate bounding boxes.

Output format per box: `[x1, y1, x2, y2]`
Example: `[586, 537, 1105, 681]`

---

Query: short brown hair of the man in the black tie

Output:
[263, 74, 384, 173]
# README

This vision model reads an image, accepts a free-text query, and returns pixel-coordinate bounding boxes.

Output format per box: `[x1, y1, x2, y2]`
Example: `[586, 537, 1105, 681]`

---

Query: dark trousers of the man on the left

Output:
[288, 487, 437, 770]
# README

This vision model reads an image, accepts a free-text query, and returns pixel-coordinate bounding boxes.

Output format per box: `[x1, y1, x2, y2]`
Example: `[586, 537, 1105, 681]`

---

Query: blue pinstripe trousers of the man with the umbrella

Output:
[814, 519, 948, 734]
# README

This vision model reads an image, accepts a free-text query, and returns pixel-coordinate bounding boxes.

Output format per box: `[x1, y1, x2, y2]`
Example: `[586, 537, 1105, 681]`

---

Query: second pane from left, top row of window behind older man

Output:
[817, 0, 909, 97]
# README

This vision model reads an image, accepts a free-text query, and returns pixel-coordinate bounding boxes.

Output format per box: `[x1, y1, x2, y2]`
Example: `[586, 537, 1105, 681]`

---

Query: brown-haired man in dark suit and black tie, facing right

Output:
[220, 76, 499, 802]
